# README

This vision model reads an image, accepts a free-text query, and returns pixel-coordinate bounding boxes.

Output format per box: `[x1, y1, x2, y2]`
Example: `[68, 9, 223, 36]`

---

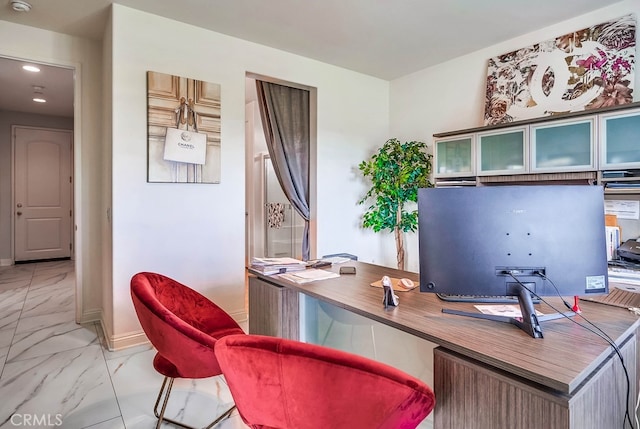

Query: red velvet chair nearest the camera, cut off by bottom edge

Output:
[215, 335, 435, 429]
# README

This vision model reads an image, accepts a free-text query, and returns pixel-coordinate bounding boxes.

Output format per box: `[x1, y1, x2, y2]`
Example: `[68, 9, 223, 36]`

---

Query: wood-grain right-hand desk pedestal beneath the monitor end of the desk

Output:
[434, 335, 636, 429]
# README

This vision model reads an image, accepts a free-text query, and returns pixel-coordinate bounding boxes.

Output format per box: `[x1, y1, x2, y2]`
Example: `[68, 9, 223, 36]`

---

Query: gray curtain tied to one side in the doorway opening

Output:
[256, 80, 310, 261]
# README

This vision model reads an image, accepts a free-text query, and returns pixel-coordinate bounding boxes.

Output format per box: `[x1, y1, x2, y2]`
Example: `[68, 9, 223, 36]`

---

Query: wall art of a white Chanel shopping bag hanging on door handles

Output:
[147, 71, 221, 183]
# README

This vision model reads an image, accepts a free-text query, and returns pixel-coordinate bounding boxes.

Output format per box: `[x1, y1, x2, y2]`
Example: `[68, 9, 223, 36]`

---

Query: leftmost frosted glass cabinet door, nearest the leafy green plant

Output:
[434, 134, 475, 177]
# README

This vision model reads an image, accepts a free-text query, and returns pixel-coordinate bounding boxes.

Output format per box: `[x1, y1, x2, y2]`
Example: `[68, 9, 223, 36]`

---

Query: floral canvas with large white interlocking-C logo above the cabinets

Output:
[484, 14, 636, 125]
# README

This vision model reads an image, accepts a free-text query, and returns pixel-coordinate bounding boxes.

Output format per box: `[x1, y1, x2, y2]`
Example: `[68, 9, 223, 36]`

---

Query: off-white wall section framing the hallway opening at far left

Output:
[0, 21, 102, 320]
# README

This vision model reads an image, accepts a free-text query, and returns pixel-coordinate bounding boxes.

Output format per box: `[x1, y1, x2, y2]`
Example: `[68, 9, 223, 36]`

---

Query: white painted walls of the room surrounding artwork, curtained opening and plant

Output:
[6, 0, 640, 342]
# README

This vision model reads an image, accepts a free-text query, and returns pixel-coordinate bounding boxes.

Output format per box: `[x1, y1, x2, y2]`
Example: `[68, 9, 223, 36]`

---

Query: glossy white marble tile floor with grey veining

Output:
[0, 261, 247, 429]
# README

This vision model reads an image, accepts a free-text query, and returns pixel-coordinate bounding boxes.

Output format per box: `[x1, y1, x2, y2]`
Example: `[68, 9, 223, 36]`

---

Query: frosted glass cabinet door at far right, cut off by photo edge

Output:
[600, 110, 640, 170]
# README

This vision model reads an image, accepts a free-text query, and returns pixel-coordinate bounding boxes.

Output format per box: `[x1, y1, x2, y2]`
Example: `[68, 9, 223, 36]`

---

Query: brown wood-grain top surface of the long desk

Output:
[252, 262, 640, 393]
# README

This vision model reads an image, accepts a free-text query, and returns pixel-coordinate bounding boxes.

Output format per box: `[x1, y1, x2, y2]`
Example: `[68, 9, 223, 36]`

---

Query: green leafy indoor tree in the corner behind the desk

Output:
[358, 139, 433, 270]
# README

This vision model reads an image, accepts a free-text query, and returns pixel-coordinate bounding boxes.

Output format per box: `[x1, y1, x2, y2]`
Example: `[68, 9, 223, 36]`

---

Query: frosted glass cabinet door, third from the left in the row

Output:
[531, 117, 595, 172]
